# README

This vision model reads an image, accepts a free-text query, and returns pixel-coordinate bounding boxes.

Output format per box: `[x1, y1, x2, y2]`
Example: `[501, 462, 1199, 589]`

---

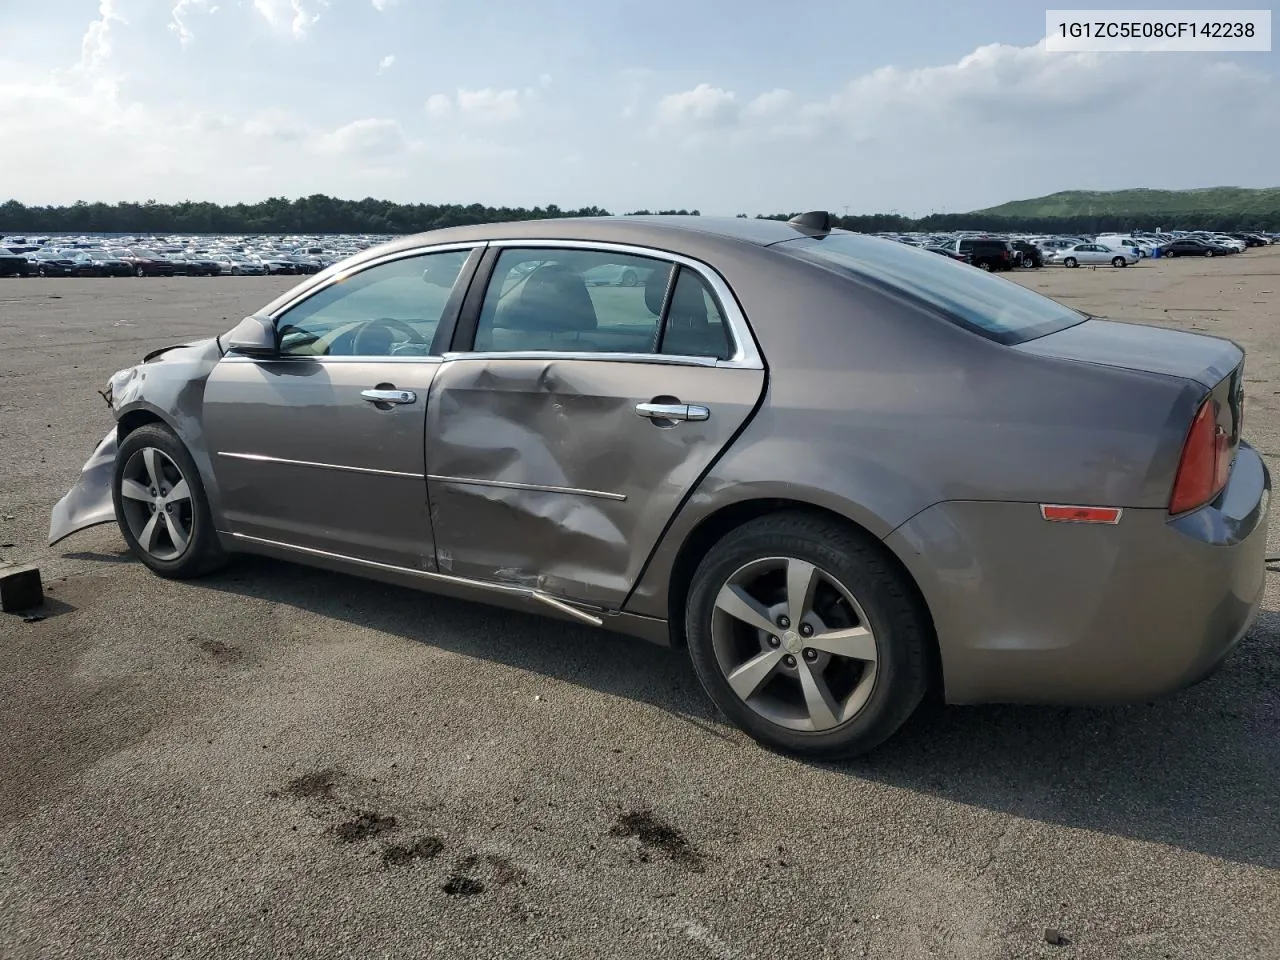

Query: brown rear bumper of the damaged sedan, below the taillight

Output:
[887, 444, 1271, 704]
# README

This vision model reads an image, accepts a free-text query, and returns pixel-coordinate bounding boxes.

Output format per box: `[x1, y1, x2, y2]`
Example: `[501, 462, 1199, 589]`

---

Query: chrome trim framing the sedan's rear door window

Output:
[444, 238, 764, 370]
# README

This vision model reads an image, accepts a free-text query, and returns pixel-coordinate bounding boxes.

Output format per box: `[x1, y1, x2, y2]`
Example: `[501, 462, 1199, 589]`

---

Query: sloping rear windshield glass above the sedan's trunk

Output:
[773, 233, 1088, 343]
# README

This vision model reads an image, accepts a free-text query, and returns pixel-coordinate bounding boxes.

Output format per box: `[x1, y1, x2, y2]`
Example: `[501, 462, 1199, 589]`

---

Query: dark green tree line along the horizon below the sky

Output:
[0, 193, 1280, 236]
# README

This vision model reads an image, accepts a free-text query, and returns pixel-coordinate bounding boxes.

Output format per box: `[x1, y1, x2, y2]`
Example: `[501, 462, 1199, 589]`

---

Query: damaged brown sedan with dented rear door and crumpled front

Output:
[50, 212, 1270, 756]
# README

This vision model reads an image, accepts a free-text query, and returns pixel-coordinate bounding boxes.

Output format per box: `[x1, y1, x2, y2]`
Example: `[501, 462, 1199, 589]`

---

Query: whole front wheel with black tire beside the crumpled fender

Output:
[111, 424, 227, 580]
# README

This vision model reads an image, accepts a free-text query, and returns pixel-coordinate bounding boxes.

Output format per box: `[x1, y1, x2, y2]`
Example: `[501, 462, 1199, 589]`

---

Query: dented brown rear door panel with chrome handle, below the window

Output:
[426, 355, 764, 608]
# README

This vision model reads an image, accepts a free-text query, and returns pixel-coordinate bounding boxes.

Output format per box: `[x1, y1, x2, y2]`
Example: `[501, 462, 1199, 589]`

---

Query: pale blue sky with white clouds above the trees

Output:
[0, 0, 1280, 216]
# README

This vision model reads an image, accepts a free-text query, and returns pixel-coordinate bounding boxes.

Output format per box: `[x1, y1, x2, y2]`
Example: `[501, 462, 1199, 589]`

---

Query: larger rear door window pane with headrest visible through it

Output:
[465, 247, 673, 353]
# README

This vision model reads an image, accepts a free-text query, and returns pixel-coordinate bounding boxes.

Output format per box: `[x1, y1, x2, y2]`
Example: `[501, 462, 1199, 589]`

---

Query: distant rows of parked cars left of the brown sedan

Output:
[0, 236, 384, 276]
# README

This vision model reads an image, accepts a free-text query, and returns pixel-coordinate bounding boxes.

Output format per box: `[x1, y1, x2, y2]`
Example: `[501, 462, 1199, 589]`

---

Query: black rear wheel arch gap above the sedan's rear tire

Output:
[667, 497, 943, 694]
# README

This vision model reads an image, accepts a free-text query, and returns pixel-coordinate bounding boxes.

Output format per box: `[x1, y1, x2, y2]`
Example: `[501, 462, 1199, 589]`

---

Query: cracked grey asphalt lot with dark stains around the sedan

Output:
[0, 256, 1280, 960]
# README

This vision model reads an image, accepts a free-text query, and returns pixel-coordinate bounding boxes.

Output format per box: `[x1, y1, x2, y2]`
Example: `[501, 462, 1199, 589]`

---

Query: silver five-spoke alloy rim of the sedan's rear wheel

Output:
[712, 557, 879, 732]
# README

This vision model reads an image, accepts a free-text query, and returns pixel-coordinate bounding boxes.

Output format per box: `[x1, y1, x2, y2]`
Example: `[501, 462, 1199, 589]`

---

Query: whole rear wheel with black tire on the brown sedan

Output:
[685, 512, 929, 758]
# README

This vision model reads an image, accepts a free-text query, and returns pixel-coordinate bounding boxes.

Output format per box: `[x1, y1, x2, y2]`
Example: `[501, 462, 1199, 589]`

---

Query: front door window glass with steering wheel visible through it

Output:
[276, 250, 470, 357]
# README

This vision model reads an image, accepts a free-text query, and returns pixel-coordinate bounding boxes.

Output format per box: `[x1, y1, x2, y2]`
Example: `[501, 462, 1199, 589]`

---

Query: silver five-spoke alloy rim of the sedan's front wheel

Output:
[120, 447, 195, 562]
